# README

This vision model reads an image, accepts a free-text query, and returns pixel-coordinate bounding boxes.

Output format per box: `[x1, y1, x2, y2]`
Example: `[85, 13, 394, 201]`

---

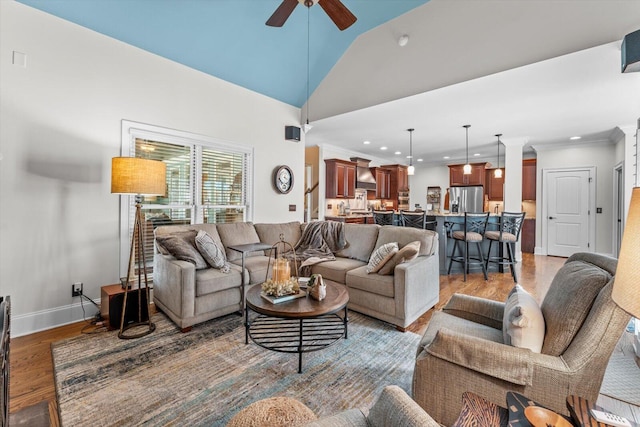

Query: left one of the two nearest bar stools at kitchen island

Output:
[447, 212, 489, 282]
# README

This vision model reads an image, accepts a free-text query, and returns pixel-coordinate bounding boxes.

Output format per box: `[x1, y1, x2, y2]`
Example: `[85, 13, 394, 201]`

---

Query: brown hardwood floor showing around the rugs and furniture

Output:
[10, 254, 640, 426]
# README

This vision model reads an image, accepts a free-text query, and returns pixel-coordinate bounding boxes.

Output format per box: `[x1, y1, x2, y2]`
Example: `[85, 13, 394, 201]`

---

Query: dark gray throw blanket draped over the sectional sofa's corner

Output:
[283, 221, 346, 276]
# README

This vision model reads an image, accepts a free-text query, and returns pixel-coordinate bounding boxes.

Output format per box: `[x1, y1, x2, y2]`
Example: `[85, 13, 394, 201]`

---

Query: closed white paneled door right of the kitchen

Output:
[545, 169, 592, 257]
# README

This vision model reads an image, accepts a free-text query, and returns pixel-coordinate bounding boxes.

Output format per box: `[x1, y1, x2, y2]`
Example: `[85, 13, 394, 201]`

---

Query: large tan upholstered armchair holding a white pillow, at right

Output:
[413, 253, 629, 425]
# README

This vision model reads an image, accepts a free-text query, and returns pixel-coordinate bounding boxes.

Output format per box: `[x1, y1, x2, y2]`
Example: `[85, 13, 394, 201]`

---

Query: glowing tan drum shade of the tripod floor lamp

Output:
[111, 157, 167, 196]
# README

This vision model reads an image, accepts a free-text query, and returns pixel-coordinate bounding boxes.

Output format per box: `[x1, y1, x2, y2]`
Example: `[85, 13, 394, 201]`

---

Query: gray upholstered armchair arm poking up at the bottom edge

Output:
[367, 385, 440, 427]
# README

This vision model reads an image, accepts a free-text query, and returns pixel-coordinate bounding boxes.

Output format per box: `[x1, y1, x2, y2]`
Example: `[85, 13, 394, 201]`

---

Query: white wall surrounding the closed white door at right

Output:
[536, 144, 617, 254]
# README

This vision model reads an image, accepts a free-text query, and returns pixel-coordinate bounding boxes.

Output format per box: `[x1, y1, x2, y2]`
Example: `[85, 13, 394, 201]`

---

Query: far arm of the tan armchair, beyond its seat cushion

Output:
[442, 294, 505, 329]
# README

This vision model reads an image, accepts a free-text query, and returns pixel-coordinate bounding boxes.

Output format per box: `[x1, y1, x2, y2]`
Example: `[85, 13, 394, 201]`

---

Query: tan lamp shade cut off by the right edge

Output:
[611, 187, 640, 318]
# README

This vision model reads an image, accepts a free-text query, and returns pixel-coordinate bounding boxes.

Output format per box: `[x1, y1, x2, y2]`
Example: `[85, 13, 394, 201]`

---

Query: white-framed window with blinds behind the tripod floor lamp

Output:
[120, 121, 253, 277]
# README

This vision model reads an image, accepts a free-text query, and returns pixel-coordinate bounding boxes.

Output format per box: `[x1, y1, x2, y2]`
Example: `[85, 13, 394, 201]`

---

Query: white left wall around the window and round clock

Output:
[0, 1, 304, 335]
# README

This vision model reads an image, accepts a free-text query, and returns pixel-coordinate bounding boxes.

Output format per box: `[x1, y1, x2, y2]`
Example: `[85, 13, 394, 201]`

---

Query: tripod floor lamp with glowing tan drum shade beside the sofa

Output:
[111, 157, 167, 339]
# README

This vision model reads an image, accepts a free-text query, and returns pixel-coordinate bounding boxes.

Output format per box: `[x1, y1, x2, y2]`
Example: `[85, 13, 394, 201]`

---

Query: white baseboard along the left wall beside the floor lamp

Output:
[11, 299, 100, 337]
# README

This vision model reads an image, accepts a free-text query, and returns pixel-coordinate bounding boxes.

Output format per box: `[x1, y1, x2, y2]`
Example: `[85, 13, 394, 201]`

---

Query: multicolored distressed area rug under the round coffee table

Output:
[52, 312, 420, 426]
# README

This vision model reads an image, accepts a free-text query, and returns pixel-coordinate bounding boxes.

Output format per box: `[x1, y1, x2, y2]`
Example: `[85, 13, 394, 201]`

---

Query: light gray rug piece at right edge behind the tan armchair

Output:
[600, 351, 640, 406]
